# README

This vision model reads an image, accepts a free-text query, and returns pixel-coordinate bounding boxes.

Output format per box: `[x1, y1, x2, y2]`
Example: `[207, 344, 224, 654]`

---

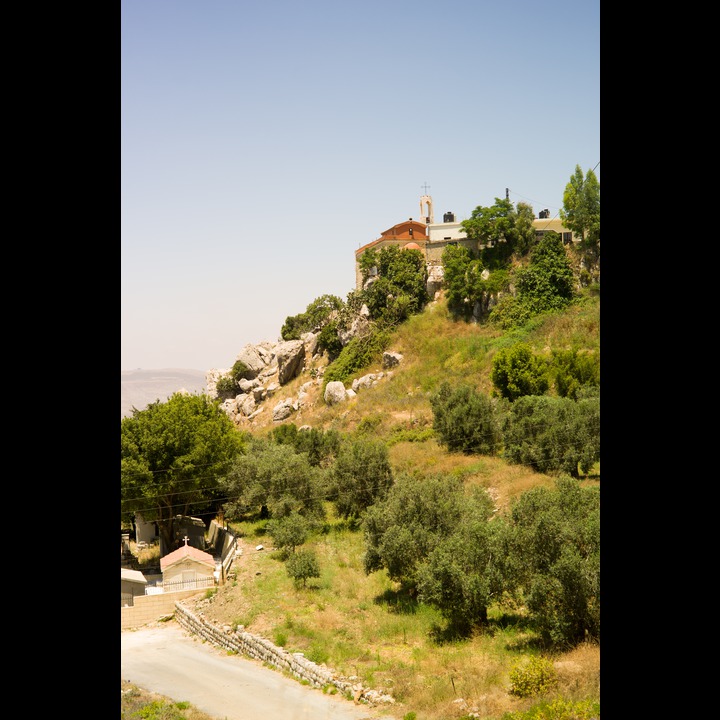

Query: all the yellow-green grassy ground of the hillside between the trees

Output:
[126, 300, 600, 720]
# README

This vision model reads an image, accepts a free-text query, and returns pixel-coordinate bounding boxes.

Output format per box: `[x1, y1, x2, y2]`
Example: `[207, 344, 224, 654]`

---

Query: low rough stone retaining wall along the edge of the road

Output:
[175, 602, 395, 705]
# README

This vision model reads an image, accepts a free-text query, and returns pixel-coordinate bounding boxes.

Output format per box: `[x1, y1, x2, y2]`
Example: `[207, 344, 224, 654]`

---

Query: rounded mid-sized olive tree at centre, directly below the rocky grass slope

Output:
[330, 438, 393, 519]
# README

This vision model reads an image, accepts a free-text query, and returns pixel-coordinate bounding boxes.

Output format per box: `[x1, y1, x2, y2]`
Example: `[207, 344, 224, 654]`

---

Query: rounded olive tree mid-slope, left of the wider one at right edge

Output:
[430, 381, 502, 455]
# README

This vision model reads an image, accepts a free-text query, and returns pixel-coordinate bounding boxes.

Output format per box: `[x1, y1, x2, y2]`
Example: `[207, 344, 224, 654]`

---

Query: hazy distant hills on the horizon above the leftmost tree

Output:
[120, 368, 206, 418]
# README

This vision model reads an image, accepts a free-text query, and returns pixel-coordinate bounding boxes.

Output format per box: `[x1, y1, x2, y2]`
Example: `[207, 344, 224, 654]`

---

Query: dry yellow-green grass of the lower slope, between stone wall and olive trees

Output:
[183, 498, 600, 720]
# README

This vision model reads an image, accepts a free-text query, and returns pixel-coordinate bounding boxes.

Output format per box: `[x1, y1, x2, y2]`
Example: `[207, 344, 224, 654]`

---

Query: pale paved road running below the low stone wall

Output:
[120, 621, 388, 720]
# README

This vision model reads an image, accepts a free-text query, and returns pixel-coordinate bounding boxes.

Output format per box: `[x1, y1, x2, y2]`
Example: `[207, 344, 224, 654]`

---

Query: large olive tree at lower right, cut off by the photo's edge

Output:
[508, 476, 600, 648]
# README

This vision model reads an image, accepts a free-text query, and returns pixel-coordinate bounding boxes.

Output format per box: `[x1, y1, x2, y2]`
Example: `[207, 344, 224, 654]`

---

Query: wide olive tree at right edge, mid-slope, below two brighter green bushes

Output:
[503, 394, 600, 478]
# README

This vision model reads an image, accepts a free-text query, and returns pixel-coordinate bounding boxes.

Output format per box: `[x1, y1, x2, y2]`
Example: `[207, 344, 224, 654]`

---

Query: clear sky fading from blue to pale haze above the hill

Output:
[120, 0, 600, 371]
